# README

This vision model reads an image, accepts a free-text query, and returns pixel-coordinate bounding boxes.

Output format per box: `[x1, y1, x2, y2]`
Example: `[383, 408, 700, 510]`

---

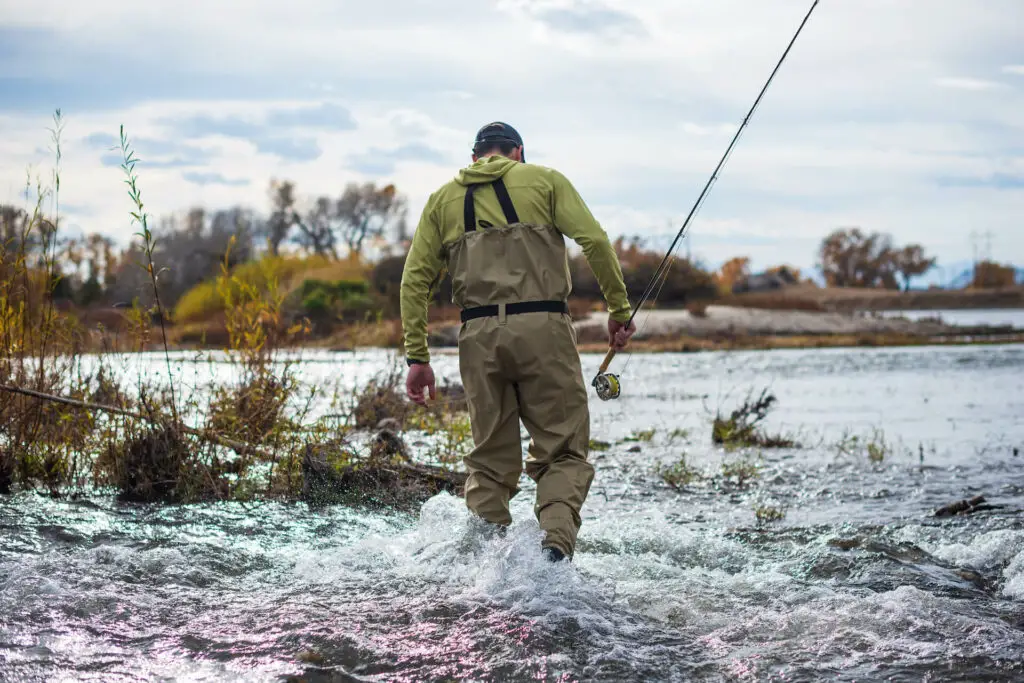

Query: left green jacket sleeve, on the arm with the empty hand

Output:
[399, 198, 444, 362]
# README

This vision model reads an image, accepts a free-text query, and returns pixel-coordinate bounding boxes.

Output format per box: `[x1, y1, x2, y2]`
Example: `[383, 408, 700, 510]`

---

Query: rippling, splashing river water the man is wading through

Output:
[0, 346, 1024, 681]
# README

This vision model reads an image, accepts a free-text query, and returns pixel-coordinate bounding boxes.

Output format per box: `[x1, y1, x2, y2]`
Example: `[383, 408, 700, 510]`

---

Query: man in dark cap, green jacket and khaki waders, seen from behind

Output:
[401, 122, 636, 561]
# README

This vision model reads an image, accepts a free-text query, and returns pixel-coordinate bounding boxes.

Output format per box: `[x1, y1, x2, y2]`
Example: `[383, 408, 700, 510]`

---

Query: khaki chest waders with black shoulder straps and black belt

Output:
[449, 179, 594, 557]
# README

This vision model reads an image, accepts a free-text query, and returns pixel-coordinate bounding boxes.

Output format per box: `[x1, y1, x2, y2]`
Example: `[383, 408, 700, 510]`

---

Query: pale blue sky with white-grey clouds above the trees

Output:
[0, 0, 1024, 282]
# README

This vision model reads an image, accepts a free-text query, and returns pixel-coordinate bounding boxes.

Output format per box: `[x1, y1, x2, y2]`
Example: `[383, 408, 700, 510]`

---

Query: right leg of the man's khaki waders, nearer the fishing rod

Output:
[517, 313, 594, 557]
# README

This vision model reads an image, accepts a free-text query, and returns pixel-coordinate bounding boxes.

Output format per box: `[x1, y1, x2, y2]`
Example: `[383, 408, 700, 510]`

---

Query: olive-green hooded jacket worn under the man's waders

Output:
[401, 155, 632, 361]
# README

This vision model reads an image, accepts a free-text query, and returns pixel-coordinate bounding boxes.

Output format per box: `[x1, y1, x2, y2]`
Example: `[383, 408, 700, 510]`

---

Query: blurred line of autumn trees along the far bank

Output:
[0, 180, 1016, 325]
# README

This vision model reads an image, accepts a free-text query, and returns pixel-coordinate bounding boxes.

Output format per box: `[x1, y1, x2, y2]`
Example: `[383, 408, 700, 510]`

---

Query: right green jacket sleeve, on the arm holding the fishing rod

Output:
[551, 169, 632, 323]
